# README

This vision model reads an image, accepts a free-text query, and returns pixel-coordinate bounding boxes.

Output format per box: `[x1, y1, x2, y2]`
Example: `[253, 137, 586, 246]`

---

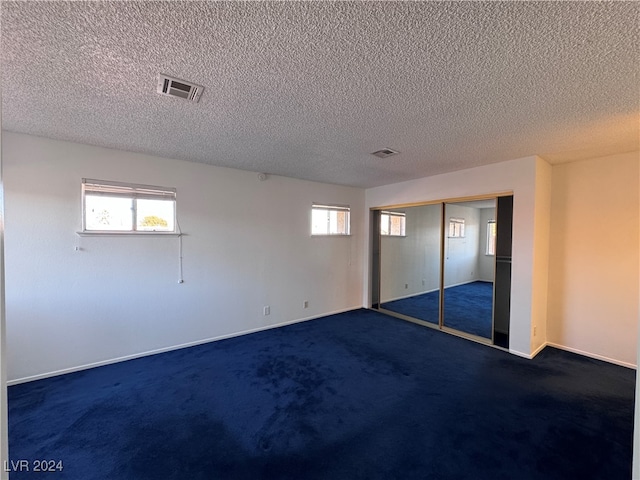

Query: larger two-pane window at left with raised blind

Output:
[82, 178, 176, 233]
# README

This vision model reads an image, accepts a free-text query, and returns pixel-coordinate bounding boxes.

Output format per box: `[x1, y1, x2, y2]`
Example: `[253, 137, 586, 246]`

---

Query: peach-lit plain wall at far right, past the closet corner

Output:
[547, 152, 640, 366]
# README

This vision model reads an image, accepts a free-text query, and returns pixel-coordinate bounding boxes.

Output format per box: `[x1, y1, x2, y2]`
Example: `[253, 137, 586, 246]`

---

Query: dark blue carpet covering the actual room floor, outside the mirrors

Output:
[9, 310, 635, 480]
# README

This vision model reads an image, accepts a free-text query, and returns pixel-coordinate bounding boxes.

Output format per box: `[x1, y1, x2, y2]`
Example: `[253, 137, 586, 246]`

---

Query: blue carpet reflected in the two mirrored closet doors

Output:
[381, 281, 493, 338]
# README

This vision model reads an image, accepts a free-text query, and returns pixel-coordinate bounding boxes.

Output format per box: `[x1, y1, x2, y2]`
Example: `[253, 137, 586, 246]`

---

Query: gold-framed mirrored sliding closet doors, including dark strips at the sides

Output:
[371, 196, 513, 346]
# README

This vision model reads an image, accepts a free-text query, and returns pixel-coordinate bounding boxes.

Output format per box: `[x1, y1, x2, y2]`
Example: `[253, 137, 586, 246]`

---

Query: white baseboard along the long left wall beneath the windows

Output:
[7, 305, 363, 387]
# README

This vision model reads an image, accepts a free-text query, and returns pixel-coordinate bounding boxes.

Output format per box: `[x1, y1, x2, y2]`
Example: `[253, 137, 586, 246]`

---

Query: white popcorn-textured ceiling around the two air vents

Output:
[0, 1, 640, 187]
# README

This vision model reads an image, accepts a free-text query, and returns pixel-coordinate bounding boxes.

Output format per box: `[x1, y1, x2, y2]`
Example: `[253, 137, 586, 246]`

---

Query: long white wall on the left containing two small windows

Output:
[2, 132, 365, 380]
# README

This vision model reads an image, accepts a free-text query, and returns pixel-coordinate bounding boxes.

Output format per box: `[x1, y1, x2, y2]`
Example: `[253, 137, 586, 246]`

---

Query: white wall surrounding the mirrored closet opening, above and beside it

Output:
[363, 157, 549, 356]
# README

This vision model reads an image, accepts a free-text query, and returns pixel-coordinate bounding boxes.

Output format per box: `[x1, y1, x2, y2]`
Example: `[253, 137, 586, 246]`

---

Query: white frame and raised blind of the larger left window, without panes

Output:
[78, 178, 180, 236]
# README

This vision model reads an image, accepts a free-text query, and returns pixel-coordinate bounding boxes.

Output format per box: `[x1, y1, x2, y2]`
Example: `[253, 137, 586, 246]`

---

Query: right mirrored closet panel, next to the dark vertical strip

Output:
[442, 199, 496, 339]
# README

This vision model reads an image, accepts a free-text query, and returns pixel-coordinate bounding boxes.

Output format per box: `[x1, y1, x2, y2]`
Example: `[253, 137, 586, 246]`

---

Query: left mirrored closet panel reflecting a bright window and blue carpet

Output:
[380, 204, 442, 325]
